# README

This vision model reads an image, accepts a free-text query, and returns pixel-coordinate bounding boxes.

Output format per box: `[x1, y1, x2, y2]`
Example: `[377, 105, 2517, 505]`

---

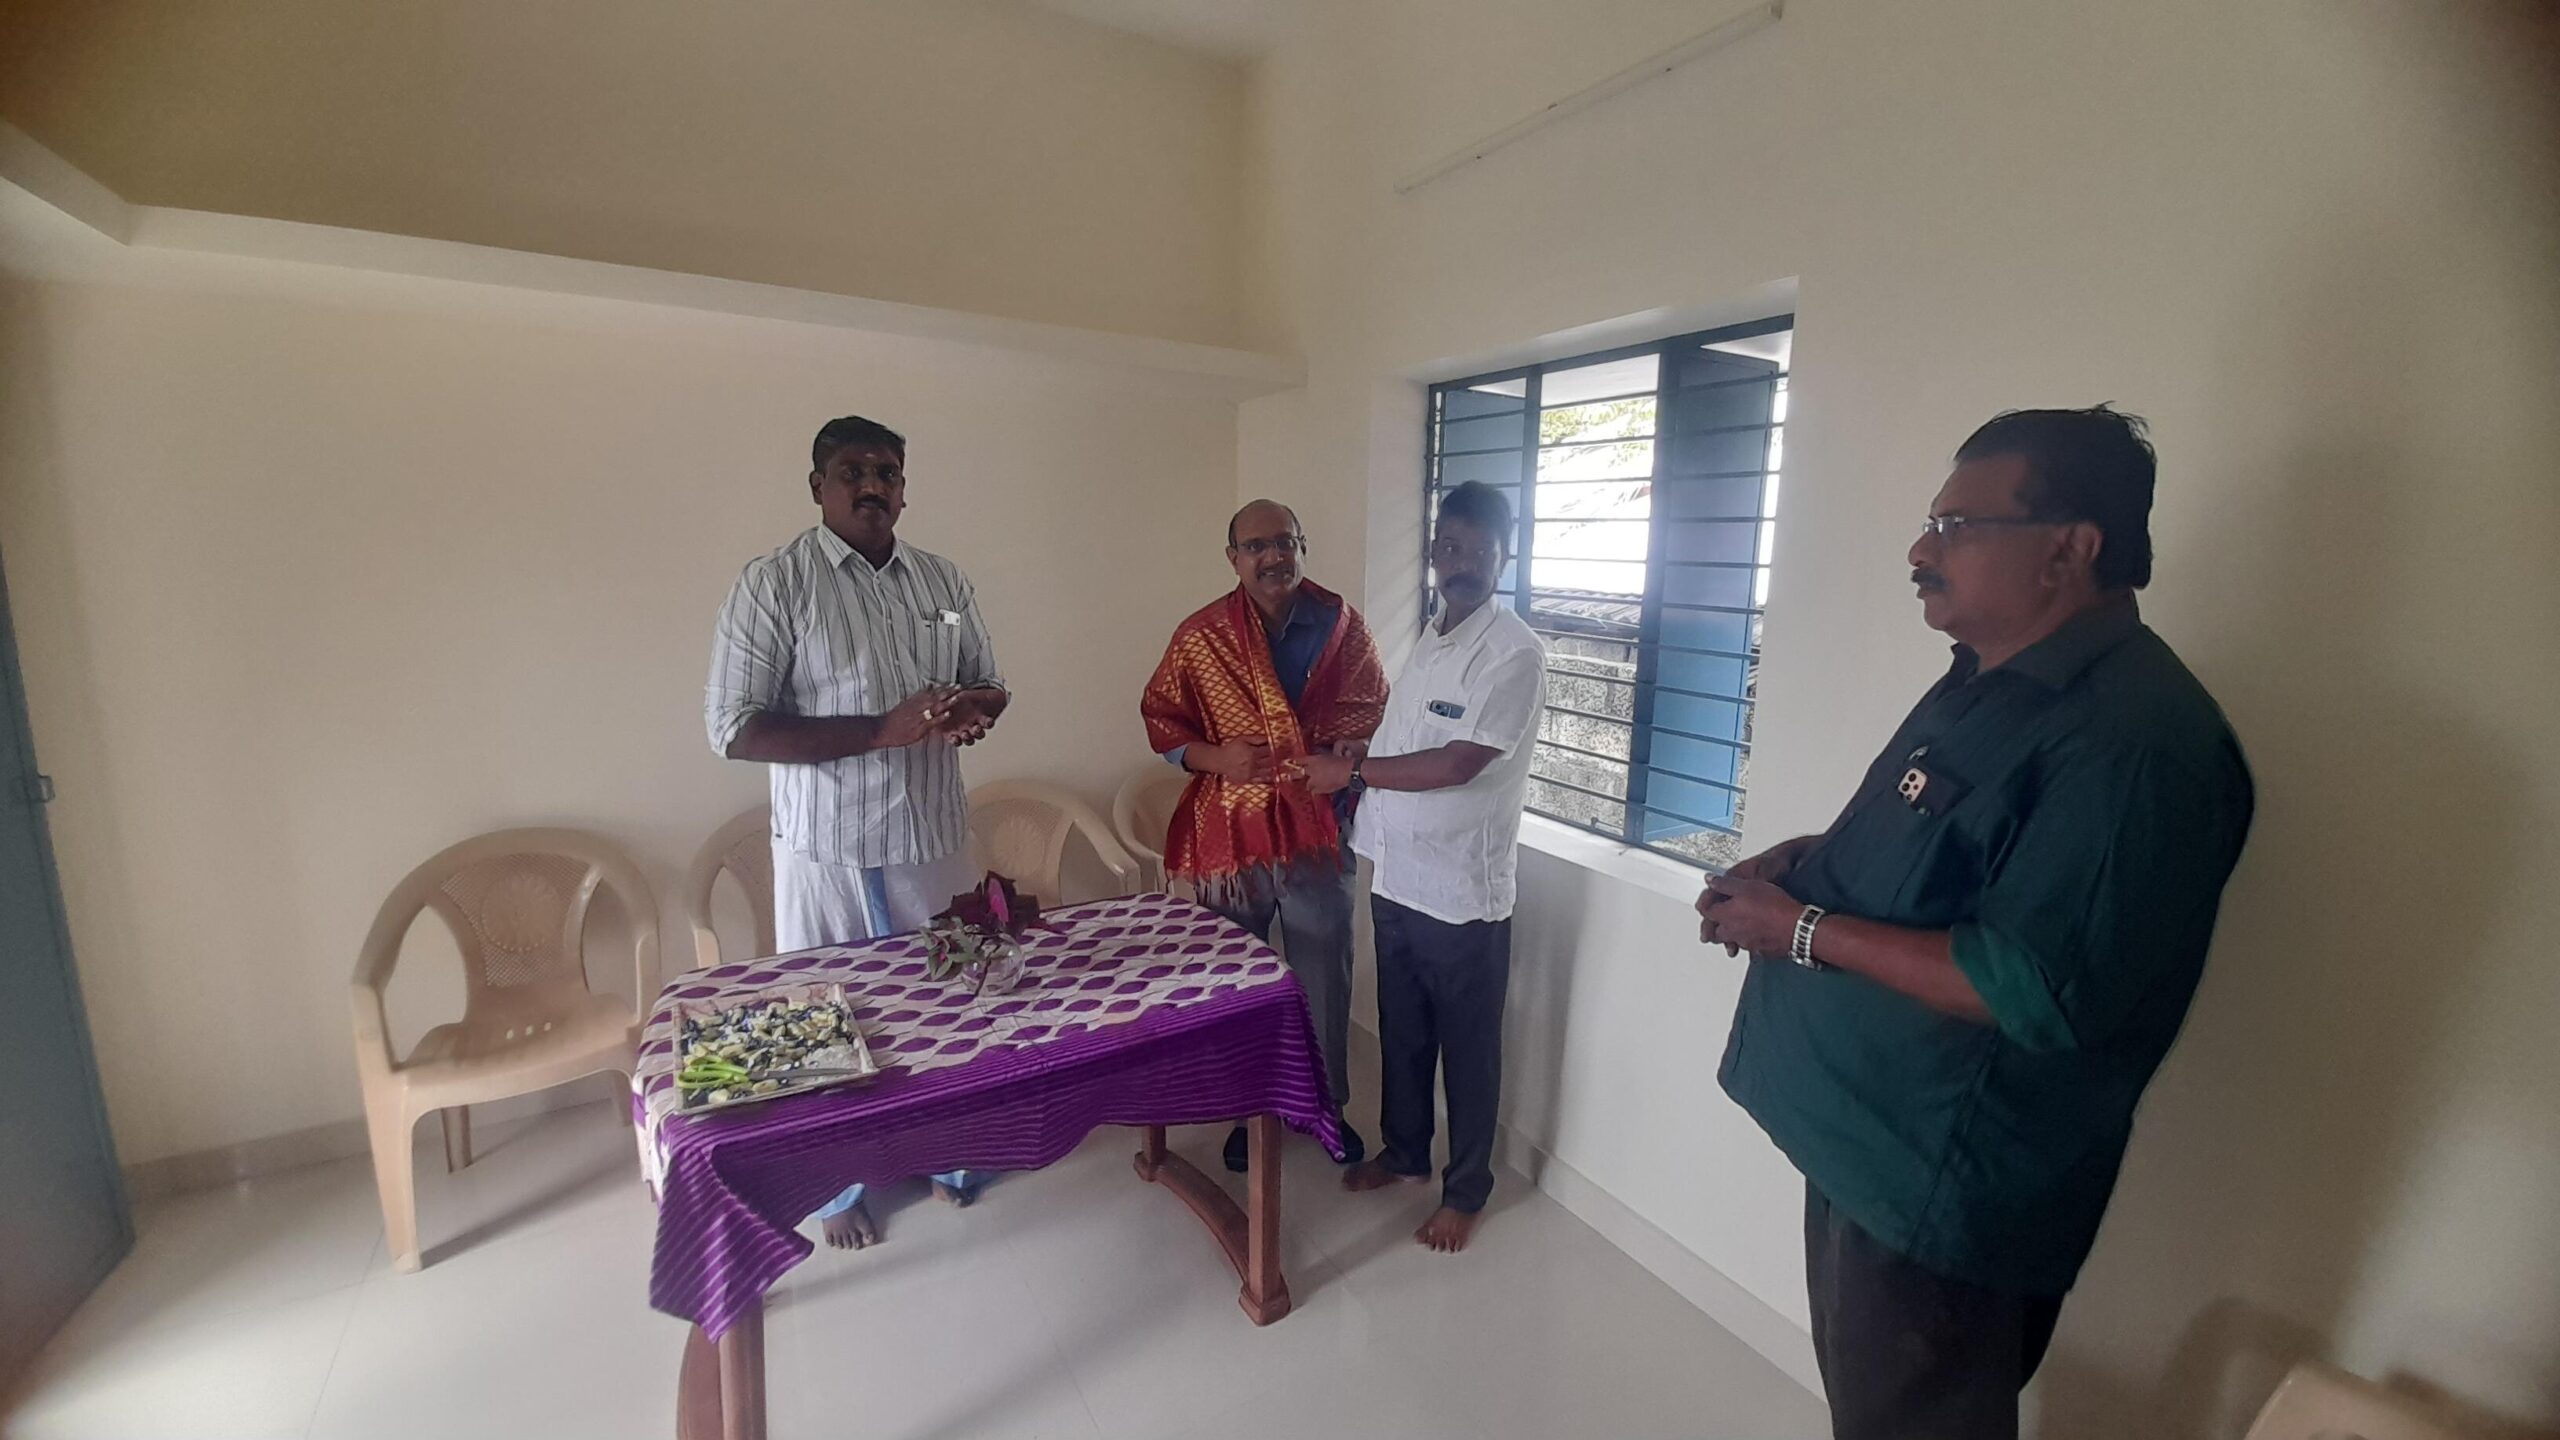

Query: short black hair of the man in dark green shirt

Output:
[1956, 405, 2161, 589]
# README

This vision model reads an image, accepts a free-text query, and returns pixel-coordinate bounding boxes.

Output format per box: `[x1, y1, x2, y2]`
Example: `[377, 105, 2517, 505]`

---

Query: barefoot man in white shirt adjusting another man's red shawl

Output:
[1295, 482, 1546, 1253]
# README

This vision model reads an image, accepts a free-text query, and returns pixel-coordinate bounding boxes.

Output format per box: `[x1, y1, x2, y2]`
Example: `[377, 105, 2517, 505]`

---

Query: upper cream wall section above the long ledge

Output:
[0, 0, 1244, 343]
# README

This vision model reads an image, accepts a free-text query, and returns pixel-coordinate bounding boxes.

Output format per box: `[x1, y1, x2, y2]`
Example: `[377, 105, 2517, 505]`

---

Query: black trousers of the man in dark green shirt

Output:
[1805, 1184, 2063, 1440]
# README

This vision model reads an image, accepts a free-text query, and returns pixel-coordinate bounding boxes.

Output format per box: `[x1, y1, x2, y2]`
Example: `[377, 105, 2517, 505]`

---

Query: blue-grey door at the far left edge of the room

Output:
[0, 543, 133, 1389]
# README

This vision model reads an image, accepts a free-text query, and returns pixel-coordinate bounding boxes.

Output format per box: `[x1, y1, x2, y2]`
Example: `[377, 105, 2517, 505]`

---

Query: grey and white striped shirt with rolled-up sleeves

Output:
[701, 525, 1004, 869]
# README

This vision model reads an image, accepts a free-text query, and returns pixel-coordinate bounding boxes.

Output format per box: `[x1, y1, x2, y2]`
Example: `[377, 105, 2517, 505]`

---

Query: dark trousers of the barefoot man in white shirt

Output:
[1370, 894, 1510, 1215]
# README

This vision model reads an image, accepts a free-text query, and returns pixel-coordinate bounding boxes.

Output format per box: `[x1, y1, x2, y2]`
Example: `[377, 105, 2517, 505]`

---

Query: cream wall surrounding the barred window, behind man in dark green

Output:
[1242, 0, 2560, 1437]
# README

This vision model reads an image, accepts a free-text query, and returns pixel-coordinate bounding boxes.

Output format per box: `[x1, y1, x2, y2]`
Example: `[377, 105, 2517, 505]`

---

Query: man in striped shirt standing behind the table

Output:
[701, 415, 1009, 1250]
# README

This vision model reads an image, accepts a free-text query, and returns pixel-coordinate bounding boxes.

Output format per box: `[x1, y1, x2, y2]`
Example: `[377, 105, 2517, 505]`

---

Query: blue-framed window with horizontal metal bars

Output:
[1423, 315, 1795, 869]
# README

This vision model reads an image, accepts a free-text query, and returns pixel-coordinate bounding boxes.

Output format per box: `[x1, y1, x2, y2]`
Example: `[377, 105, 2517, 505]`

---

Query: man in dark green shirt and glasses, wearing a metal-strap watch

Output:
[1697, 407, 2253, 1440]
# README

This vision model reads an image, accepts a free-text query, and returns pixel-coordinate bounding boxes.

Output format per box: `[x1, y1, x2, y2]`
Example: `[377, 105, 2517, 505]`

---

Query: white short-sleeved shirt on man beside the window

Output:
[1352, 600, 1546, 925]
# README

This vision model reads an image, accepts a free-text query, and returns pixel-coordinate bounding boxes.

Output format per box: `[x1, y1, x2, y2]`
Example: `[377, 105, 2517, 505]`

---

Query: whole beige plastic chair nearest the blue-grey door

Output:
[351, 830, 658, 1271]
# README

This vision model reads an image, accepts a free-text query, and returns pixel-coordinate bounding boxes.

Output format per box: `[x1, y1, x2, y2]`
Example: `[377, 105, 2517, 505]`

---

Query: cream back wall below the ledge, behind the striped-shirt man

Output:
[0, 271, 1234, 1163]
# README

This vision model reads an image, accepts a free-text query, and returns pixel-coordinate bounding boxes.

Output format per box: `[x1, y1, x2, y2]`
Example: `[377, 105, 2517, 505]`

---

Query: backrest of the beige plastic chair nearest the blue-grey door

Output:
[356, 830, 658, 1030]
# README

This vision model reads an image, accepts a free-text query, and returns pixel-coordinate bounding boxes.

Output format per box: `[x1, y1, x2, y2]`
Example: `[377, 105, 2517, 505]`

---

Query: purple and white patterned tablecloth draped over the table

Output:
[632, 894, 1341, 1340]
